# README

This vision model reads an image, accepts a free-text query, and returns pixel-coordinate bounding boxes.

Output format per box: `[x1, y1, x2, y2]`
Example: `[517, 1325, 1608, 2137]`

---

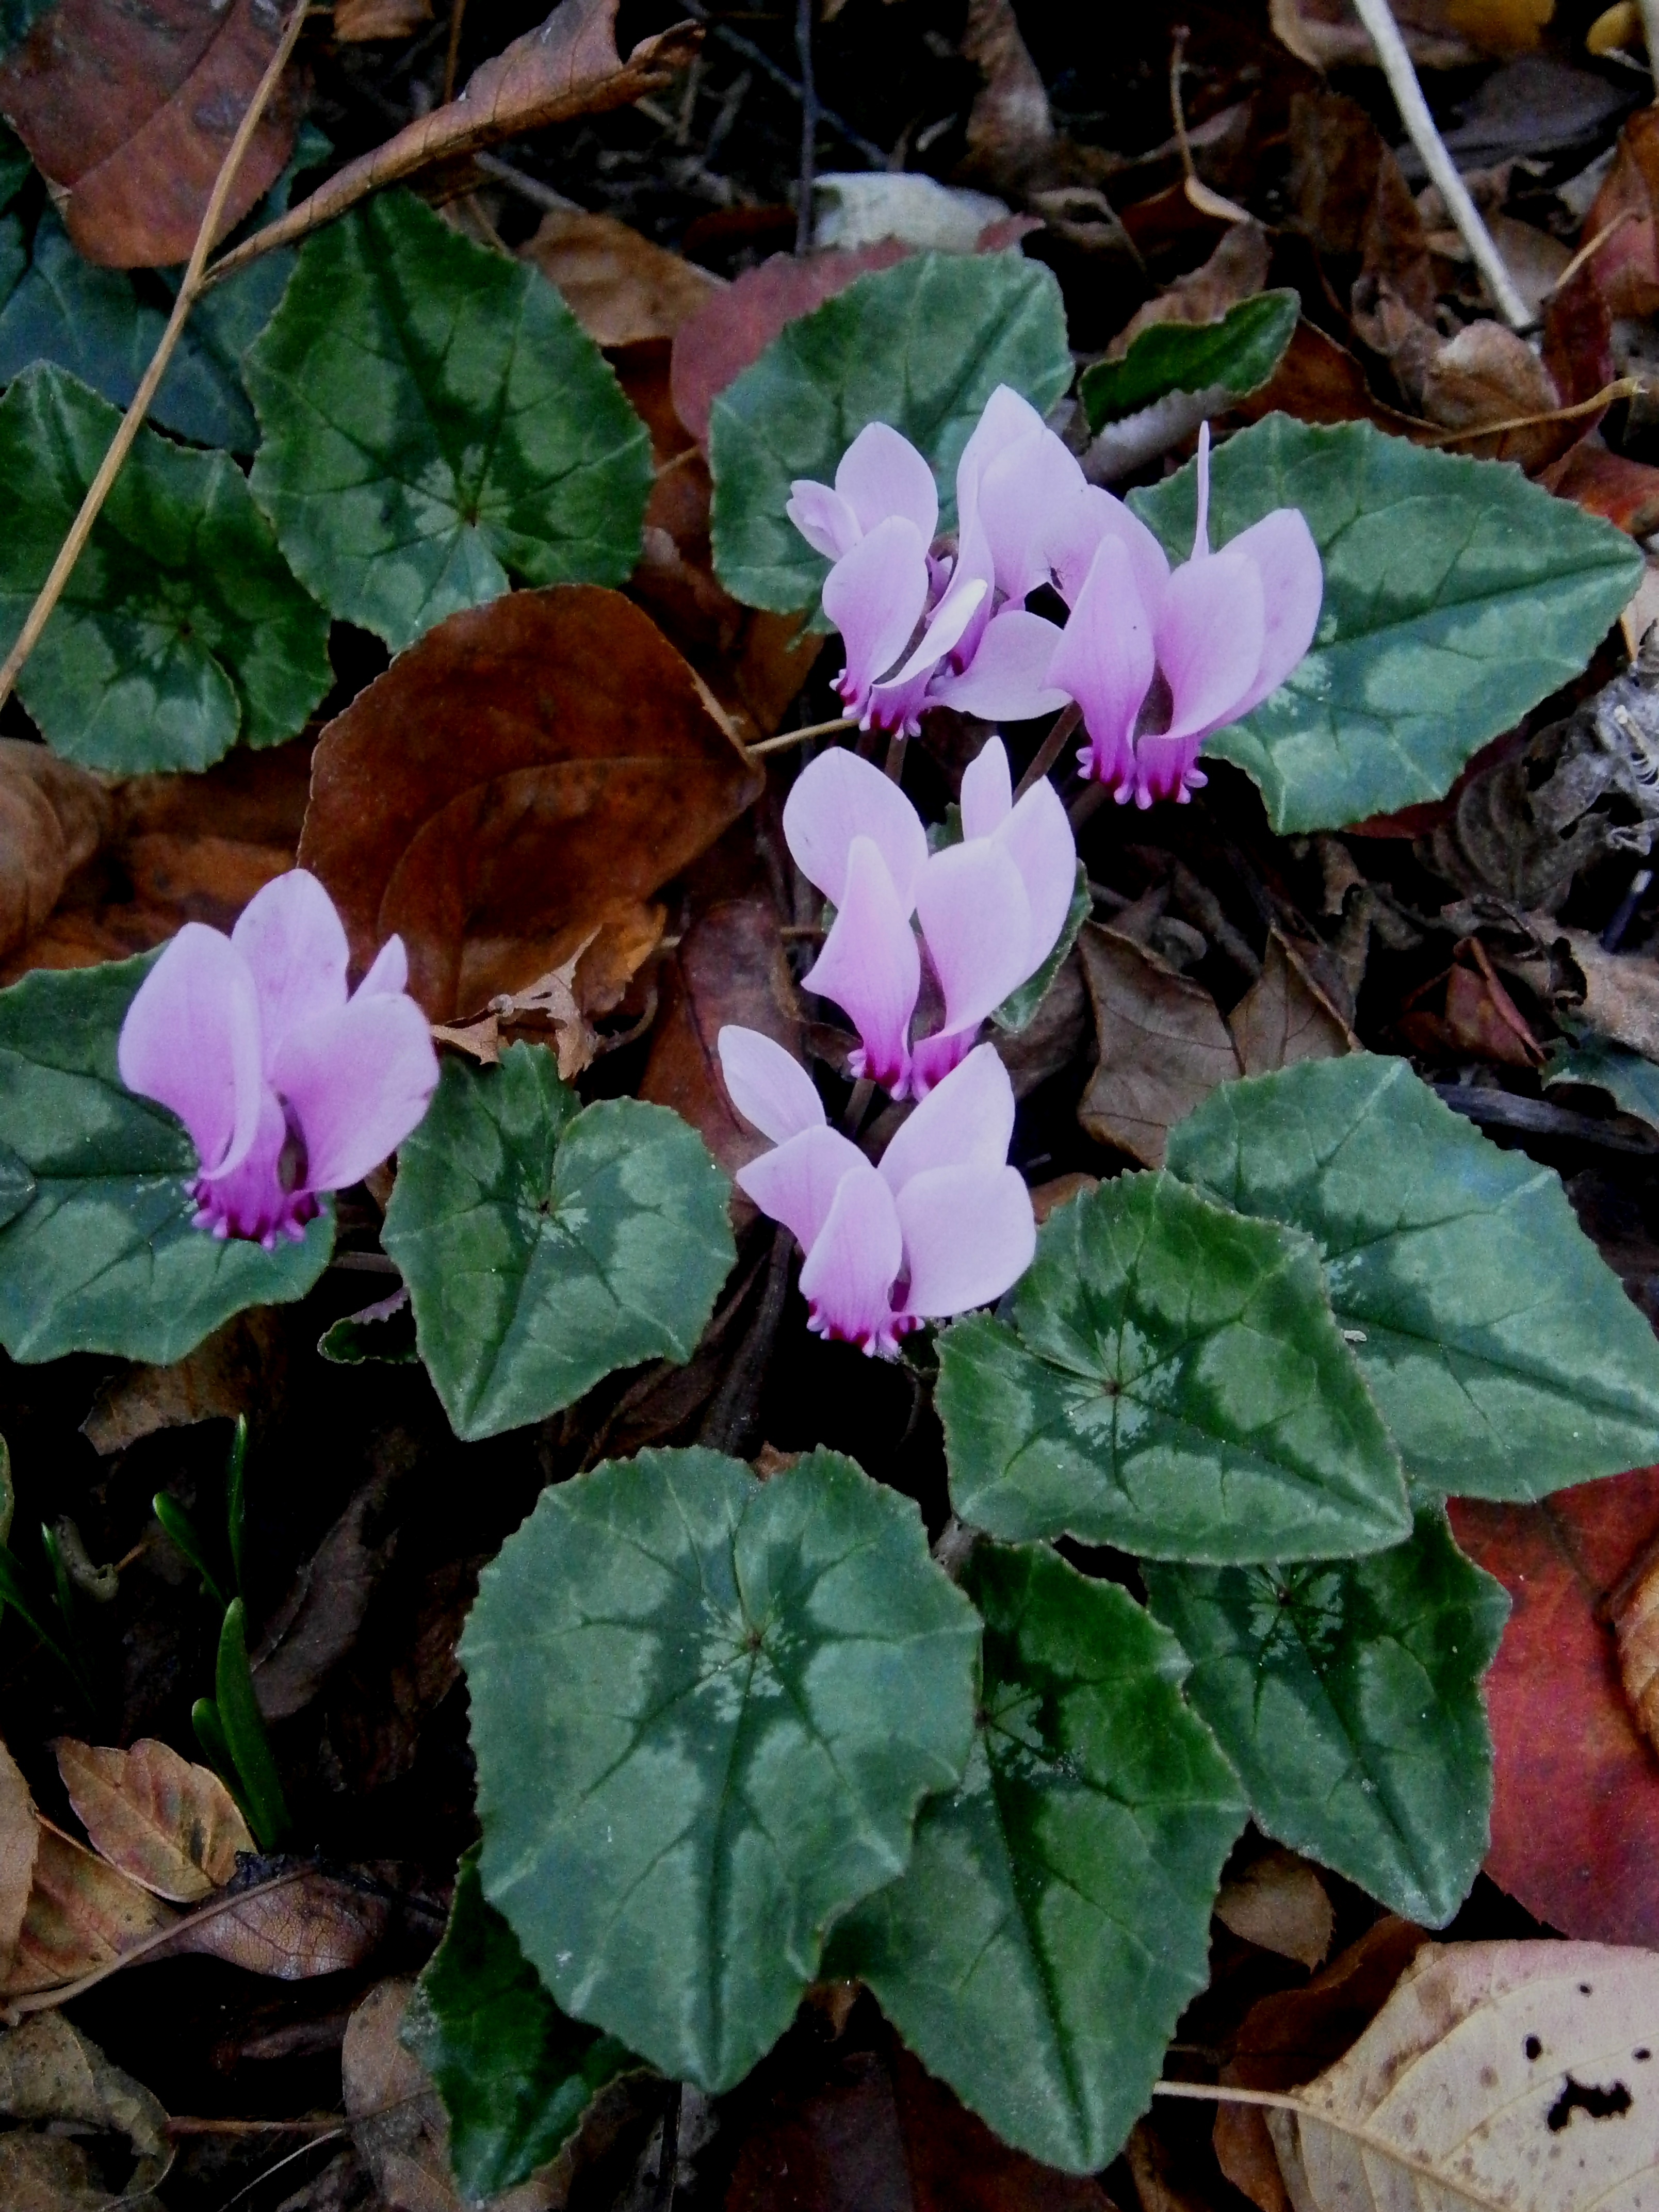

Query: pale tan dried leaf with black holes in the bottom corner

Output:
[1267, 1942, 1659, 2212]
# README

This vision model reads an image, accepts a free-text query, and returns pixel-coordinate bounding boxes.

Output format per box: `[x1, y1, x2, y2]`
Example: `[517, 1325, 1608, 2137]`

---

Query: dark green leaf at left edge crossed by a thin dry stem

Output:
[0, 365, 332, 774]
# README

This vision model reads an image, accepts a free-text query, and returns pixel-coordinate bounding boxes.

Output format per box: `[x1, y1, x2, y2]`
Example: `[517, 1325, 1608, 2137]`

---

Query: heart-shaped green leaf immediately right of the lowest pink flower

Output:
[938, 1175, 1411, 1562]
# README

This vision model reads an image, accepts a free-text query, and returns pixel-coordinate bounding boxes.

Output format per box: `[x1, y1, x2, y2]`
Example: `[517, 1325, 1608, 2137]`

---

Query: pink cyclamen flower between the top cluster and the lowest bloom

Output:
[783, 737, 1077, 1097]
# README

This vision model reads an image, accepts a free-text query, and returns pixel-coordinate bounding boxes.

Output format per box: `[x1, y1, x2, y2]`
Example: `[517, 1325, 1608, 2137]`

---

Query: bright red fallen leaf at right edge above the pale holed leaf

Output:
[1451, 1467, 1659, 1944]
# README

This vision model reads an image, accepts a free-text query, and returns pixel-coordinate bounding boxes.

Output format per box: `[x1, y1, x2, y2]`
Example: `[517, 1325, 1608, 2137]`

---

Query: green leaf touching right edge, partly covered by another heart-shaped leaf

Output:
[1168, 1053, 1659, 1500]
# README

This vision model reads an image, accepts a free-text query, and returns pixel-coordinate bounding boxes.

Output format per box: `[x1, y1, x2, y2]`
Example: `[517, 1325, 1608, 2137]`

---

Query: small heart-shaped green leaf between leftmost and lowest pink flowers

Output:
[381, 1044, 737, 1440]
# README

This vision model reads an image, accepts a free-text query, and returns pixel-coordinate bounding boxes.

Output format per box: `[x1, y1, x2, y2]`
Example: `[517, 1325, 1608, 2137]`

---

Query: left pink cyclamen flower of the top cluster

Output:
[788, 385, 1082, 730]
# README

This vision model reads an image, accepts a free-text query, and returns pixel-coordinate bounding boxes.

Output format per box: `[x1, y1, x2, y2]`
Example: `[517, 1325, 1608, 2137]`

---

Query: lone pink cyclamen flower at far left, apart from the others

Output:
[117, 867, 438, 1250]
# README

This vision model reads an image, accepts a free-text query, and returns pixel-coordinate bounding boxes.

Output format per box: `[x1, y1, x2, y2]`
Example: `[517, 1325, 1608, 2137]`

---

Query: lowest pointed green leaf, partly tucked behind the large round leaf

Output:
[827, 1544, 1245, 2172]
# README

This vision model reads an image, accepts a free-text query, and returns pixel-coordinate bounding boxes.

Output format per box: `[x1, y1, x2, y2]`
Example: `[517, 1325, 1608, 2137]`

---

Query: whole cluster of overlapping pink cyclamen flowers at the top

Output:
[788, 385, 1325, 807]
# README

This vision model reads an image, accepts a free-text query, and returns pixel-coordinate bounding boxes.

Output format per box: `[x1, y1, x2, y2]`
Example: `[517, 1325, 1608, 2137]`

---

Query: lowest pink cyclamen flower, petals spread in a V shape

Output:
[717, 1027, 1037, 1358]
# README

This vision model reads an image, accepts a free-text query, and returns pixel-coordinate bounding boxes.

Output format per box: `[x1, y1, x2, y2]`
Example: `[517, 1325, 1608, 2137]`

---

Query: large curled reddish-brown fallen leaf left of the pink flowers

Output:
[299, 584, 763, 1022]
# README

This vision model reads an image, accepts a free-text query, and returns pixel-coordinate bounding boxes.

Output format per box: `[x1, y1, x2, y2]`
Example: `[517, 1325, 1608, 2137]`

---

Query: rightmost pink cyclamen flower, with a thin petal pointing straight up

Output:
[1049, 422, 1325, 807]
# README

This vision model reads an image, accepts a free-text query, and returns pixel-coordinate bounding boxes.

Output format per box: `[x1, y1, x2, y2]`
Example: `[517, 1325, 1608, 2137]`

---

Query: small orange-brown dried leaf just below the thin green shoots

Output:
[53, 1736, 254, 1905]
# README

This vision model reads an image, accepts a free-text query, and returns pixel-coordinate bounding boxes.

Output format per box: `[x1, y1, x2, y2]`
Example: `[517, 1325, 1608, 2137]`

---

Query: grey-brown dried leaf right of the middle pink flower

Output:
[1077, 922, 1239, 1168]
